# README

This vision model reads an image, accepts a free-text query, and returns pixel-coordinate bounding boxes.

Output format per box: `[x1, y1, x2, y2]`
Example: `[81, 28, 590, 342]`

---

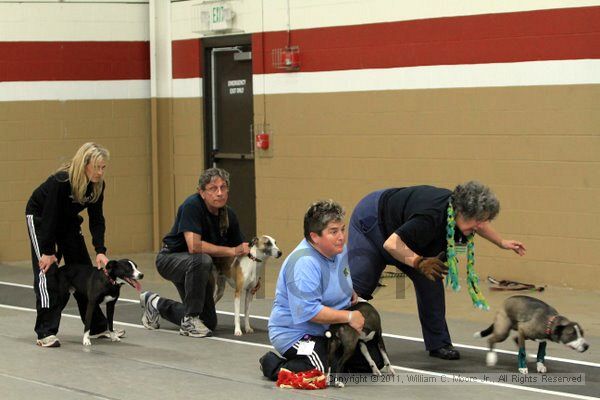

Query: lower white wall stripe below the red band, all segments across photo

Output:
[5, 60, 600, 101]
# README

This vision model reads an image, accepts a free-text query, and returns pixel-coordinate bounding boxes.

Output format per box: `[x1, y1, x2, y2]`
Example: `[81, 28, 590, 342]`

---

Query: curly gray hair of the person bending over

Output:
[452, 181, 500, 221]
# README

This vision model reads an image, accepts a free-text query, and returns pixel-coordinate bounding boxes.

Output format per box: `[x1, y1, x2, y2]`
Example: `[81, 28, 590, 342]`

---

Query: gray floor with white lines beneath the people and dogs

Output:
[0, 254, 600, 400]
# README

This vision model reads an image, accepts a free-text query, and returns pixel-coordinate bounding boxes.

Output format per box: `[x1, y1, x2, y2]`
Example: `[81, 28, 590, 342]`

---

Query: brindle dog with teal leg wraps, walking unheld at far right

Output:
[474, 296, 589, 374]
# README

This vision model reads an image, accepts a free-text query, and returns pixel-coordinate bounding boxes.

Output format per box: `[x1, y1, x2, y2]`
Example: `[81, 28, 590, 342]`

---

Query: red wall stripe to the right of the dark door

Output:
[253, 7, 600, 74]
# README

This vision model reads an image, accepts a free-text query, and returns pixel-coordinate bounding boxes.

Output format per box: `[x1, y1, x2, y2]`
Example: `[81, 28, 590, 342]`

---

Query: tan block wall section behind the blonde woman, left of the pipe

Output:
[0, 100, 152, 261]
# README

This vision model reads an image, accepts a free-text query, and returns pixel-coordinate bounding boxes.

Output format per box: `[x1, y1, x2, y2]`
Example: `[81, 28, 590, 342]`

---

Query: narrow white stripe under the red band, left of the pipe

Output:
[0, 80, 150, 101]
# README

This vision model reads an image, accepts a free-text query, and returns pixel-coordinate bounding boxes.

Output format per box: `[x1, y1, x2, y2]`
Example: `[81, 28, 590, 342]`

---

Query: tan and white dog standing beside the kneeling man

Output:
[214, 235, 281, 336]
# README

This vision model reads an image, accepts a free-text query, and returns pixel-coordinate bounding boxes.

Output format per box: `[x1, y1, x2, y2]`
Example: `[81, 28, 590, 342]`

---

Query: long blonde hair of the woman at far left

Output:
[57, 142, 110, 204]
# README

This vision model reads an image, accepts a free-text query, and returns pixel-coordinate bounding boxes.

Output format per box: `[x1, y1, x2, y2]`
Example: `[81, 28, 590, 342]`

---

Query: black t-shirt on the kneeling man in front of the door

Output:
[163, 193, 244, 253]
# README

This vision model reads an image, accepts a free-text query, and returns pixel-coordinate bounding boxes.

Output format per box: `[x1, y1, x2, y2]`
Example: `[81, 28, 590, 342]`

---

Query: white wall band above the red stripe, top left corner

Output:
[0, 2, 149, 42]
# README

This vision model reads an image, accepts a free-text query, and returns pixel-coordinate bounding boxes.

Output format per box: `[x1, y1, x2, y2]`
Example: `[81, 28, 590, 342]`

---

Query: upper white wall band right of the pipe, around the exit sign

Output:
[171, 0, 600, 40]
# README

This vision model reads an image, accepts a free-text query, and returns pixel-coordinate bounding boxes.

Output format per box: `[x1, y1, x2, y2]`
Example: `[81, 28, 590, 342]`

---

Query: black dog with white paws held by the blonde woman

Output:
[58, 259, 144, 346]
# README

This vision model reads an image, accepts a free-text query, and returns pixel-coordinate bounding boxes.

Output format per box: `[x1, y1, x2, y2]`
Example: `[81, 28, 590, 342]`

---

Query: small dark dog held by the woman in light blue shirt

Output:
[325, 301, 394, 387]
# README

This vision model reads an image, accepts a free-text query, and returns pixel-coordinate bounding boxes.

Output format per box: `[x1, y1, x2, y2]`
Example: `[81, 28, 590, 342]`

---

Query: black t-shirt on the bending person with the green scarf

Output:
[379, 185, 466, 257]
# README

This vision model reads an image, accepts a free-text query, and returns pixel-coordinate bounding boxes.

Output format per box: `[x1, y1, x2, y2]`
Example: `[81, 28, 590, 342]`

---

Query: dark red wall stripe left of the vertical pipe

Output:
[0, 42, 150, 82]
